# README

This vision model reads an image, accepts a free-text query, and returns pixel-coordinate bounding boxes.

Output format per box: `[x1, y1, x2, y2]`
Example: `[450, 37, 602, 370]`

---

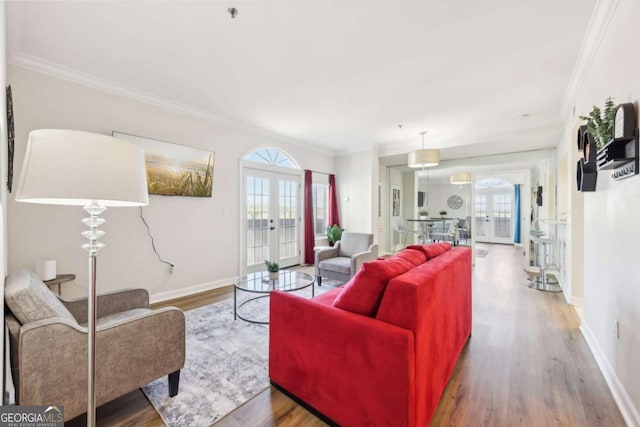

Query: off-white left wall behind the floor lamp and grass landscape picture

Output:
[8, 67, 336, 300]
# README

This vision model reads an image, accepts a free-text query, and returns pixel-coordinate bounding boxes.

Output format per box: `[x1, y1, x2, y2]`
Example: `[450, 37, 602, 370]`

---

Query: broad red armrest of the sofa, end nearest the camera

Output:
[269, 291, 415, 425]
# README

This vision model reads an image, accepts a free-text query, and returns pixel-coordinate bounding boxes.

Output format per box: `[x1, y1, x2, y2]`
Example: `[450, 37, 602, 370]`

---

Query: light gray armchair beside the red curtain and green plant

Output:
[315, 231, 378, 286]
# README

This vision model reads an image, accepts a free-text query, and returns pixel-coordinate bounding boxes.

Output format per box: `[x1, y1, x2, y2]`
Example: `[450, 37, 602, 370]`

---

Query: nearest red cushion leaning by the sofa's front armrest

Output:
[333, 258, 413, 317]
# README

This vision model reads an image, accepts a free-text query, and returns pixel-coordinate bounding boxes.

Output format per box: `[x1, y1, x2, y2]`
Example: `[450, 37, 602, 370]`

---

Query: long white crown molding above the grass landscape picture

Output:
[8, 52, 336, 156]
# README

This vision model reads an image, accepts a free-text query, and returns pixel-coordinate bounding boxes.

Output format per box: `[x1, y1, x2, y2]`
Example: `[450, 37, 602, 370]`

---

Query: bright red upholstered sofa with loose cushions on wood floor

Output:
[269, 243, 471, 426]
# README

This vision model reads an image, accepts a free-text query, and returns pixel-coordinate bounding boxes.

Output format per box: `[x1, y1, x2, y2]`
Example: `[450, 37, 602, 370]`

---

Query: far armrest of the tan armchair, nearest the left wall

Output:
[58, 289, 149, 323]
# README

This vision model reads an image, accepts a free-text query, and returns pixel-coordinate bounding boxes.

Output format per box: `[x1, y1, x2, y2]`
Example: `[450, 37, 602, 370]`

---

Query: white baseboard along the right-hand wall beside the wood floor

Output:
[580, 322, 640, 427]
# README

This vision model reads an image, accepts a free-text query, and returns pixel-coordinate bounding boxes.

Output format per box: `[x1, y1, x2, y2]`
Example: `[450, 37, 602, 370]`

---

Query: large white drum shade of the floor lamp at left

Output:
[16, 129, 149, 207]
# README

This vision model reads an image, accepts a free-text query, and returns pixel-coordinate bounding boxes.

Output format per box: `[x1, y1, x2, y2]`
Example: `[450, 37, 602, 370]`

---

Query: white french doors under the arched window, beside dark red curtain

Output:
[243, 168, 301, 273]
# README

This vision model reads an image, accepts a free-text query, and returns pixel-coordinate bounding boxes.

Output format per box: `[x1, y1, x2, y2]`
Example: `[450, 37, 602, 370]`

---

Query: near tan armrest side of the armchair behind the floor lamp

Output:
[17, 307, 185, 420]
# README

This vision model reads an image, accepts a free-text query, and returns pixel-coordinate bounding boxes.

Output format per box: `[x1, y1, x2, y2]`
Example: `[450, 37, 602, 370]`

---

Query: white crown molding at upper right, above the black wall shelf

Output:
[560, 0, 620, 121]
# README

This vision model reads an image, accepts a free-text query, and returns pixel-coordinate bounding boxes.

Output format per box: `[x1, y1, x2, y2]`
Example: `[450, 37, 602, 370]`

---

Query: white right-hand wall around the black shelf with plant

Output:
[561, 0, 640, 426]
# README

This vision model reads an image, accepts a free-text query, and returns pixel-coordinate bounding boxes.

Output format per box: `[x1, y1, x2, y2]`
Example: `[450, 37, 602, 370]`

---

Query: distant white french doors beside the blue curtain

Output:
[475, 188, 514, 243]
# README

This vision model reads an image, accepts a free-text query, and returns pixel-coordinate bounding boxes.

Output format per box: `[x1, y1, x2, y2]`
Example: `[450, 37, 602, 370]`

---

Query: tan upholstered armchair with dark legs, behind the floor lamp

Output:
[5, 270, 185, 421]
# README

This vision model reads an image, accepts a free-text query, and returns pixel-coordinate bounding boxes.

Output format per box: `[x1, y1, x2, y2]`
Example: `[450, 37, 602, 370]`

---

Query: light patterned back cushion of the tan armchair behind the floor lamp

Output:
[4, 270, 77, 325]
